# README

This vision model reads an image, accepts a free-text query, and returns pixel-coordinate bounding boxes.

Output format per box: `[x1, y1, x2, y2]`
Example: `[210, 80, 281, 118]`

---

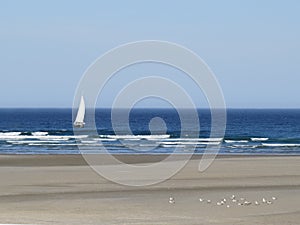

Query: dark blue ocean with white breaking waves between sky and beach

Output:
[0, 109, 300, 154]
